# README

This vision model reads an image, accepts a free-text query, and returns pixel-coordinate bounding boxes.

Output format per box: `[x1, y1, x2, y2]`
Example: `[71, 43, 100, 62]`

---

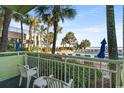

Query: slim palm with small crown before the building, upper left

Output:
[13, 13, 24, 47]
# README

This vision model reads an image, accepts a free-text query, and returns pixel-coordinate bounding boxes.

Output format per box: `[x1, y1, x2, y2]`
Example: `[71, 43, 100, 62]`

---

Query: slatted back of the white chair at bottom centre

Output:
[44, 77, 73, 88]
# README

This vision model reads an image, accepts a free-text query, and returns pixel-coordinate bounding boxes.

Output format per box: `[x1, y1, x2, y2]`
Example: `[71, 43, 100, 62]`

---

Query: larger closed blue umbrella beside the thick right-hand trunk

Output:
[97, 38, 106, 58]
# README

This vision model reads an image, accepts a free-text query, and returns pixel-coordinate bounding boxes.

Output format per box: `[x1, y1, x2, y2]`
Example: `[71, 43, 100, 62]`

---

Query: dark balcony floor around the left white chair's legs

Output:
[0, 76, 35, 88]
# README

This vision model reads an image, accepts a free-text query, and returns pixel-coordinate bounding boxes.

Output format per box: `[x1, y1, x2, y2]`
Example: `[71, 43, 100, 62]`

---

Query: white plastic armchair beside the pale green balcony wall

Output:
[18, 65, 39, 88]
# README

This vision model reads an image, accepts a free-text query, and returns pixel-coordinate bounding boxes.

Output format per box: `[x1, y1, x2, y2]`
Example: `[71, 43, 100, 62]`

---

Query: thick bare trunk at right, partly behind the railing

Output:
[106, 5, 118, 87]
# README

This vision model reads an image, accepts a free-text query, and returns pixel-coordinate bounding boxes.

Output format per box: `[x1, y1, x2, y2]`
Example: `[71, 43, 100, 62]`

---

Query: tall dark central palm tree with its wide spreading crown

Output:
[36, 5, 76, 54]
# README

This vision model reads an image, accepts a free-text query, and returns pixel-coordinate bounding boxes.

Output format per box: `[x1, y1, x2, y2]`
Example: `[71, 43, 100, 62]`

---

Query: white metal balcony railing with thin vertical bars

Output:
[26, 53, 122, 88]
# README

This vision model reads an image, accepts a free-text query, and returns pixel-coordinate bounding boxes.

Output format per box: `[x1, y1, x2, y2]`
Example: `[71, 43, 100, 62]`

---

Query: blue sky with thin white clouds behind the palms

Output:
[11, 5, 122, 47]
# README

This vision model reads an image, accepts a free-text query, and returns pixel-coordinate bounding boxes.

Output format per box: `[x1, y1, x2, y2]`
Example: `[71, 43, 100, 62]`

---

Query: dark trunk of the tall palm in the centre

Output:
[52, 5, 60, 54]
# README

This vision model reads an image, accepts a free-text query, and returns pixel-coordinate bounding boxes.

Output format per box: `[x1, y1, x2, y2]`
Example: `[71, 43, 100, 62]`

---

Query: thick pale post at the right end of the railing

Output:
[116, 63, 121, 88]
